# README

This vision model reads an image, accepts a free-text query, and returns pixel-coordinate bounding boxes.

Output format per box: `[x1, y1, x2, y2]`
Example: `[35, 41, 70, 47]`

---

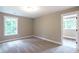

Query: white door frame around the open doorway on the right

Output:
[61, 11, 79, 49]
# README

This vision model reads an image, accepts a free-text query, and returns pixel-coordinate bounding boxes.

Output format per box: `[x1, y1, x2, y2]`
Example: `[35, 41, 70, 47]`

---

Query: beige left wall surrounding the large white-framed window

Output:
[0, 14, 33, 41]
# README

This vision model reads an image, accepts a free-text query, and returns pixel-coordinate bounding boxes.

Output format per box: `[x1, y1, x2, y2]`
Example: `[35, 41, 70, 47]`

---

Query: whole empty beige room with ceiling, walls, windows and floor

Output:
[0, 6, 79, 53]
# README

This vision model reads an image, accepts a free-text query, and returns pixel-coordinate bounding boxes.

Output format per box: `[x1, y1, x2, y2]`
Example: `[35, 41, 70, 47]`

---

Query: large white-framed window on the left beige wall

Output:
[4, 16, 18, 36]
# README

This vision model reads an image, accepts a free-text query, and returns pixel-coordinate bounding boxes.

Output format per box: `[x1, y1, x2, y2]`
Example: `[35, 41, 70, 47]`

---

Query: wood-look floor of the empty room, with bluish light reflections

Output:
[0, 37, 78, 53]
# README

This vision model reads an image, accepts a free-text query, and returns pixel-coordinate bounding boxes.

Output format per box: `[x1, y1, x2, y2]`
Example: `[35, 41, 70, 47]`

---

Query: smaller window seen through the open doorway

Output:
[64, 14, 76, 29]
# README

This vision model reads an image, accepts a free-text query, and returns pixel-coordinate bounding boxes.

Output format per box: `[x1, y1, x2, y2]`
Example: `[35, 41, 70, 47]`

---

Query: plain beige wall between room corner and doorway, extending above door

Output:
[34, 7, 79, 43]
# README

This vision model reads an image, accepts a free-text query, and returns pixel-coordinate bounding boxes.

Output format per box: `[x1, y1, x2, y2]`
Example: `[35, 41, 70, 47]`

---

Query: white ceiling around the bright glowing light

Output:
[0, 6, 72, 18]
